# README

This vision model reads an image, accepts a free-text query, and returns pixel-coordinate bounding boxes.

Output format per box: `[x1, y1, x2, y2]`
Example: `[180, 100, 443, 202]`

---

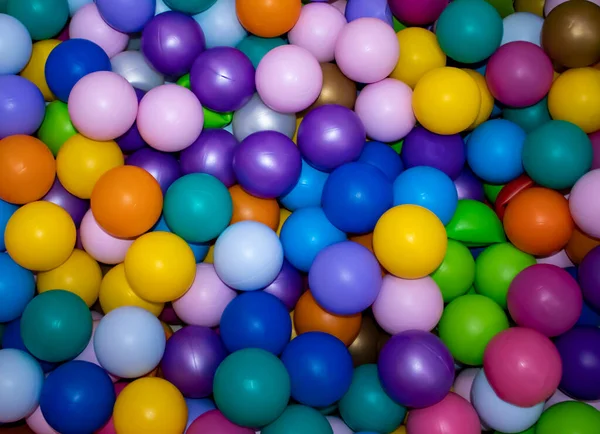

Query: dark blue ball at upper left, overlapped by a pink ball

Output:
[45, 39, 112, 103]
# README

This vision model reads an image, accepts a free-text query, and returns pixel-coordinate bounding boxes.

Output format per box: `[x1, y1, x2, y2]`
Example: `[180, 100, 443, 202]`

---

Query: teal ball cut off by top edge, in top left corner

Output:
[6, 0, 69, 41]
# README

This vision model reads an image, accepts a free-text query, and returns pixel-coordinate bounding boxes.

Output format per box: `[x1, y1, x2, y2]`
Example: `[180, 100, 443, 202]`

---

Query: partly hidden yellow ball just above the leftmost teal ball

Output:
[37, 249, 102, 306]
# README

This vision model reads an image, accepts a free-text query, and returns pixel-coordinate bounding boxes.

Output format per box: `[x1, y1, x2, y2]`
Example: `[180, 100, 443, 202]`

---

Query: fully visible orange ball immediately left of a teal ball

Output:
[91, 166, 163, 238]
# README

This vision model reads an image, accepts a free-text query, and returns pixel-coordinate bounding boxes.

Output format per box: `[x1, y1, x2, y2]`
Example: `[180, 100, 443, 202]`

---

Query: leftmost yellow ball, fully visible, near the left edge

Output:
[4, 201, 76, 271]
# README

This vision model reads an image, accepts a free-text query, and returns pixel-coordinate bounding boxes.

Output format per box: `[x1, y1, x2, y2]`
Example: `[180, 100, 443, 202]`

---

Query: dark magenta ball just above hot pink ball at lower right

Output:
[507, 264, 583, 337]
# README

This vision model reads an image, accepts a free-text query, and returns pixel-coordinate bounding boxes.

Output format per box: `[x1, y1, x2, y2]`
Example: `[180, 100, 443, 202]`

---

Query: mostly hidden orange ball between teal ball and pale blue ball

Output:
[229, 185, 279, 231]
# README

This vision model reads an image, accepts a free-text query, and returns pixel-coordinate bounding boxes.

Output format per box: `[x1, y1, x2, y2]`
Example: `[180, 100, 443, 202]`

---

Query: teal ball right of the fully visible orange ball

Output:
[163, 173, 233, 243]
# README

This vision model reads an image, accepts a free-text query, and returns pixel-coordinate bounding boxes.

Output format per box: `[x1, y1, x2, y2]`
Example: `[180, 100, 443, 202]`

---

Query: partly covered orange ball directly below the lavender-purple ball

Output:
[294, 291, 362, 346]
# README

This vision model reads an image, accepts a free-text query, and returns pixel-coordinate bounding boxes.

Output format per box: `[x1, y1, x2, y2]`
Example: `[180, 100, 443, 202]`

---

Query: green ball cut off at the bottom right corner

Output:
[535, 401, 600, 434]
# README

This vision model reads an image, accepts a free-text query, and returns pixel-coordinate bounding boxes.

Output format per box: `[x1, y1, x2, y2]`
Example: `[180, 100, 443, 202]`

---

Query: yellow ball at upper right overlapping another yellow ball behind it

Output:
[413, 67, 481, 135]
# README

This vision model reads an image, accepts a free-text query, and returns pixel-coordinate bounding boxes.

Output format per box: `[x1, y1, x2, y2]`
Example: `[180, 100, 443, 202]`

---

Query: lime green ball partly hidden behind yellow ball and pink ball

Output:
[431, 240, 475, 303]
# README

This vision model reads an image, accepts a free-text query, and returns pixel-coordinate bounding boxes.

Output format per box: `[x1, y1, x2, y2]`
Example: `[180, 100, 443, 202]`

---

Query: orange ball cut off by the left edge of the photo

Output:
[0, 134, 56, 205]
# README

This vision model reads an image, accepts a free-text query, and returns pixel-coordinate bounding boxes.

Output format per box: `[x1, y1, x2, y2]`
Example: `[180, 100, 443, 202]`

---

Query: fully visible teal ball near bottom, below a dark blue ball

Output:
[213, 348, 291, 428]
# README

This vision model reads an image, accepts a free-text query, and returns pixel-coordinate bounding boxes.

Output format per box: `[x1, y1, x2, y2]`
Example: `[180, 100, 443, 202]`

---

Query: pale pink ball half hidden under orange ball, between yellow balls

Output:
[79, 210, 134, 265]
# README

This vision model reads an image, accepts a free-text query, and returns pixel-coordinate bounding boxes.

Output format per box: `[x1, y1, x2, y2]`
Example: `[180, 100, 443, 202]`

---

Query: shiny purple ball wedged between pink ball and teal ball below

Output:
[179, 129, 239, 188]
